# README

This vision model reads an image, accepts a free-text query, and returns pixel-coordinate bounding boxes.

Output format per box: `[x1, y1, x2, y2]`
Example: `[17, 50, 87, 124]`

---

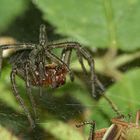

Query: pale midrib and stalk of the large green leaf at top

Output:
[102, 0, 121, 80]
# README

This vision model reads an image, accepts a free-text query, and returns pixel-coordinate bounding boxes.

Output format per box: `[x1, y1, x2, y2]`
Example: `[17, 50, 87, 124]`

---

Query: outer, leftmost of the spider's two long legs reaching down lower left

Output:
[10, 68, 35, 128]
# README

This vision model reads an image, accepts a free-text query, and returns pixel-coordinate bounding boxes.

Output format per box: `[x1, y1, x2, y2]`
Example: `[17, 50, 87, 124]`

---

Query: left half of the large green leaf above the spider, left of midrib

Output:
[36, 0, 107, 46]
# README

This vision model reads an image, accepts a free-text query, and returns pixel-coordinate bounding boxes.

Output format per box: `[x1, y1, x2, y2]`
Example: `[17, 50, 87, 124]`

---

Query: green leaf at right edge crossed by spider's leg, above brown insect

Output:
[97, 69, 140, 127]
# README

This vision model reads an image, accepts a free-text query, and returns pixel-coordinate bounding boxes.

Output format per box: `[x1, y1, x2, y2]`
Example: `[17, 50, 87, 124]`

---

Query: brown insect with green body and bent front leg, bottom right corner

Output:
[76, 111, 140, 140]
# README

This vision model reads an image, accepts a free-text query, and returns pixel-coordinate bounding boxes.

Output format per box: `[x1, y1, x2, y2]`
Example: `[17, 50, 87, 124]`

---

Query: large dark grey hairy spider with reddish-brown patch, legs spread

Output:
[0, 25, 101, 127]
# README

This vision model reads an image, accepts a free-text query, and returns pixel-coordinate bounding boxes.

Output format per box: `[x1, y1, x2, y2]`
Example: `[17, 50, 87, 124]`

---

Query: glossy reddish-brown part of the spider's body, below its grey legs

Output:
[31, 63, 67, 88]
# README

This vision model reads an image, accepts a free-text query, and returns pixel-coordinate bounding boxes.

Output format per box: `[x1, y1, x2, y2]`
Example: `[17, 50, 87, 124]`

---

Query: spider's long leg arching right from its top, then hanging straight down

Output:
[48, 42, 96, 97]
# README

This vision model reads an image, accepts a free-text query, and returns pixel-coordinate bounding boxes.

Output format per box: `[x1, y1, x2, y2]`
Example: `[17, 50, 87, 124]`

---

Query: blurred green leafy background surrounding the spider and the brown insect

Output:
[0, 0, 140, 140]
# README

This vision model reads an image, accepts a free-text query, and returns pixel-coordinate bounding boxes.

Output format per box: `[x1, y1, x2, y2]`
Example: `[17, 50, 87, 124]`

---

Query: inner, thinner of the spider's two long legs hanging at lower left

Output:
[25, 63, 37, 118]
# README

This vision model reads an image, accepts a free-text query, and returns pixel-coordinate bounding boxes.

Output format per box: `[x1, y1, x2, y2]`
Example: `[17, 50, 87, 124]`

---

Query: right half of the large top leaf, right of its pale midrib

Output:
[112, 0, 140, 50]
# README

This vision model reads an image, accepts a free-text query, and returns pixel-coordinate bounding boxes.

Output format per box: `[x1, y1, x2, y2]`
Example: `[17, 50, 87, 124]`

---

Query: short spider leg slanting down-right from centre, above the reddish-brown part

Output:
[45, 50, 74, 81]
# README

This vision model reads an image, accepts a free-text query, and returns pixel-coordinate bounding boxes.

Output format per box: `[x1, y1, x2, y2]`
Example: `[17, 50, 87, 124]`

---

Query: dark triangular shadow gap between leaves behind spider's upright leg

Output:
[1, 2, 63, 43]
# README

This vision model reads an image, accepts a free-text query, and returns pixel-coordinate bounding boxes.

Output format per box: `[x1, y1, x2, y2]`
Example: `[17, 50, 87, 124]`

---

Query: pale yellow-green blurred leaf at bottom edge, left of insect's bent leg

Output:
[41, 120, 83, 140]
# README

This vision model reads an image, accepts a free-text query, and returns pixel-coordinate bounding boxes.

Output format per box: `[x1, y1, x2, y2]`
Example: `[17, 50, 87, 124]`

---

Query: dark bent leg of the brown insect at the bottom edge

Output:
[76, 121, 96, 140]
